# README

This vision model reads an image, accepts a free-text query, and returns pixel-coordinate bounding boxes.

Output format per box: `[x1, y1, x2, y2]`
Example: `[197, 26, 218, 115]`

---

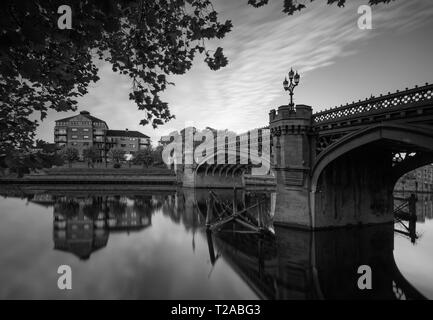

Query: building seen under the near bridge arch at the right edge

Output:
[395, 164, 433, 192]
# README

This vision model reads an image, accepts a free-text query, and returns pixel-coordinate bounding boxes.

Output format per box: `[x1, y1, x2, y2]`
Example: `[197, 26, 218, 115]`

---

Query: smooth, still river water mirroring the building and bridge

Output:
[0, 186, 433, 299]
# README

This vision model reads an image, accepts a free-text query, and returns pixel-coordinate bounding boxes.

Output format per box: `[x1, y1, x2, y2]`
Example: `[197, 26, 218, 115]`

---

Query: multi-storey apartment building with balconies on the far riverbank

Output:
[54, 111, 150, 157]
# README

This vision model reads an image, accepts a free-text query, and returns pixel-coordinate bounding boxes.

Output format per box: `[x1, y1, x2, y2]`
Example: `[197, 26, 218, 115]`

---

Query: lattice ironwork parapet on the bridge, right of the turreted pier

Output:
[313, 84, 433, 124]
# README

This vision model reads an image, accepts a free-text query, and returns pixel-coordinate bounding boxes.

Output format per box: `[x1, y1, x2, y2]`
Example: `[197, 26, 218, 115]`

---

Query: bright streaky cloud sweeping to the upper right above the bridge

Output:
[169, 1, 433, 131]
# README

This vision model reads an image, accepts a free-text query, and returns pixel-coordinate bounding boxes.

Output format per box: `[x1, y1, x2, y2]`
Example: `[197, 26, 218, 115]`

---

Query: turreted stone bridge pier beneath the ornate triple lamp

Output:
[269, 105, 314, 228]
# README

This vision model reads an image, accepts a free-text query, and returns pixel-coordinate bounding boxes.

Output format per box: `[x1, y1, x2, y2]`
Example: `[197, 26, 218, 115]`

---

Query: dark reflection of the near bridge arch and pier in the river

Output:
[209, 226, 425, 300]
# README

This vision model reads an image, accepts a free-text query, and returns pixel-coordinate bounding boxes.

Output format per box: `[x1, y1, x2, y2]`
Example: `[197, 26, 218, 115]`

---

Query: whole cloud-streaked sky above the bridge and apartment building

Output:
[37, 0, 433, 143]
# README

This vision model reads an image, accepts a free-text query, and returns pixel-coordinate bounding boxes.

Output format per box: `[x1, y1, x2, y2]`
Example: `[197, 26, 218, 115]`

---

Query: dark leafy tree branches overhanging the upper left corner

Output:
[0, 0, 232, 156]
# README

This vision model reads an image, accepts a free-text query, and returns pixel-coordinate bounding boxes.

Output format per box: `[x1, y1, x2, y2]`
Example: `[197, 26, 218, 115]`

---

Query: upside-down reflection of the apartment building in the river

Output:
[53, 196, 151, 259]
